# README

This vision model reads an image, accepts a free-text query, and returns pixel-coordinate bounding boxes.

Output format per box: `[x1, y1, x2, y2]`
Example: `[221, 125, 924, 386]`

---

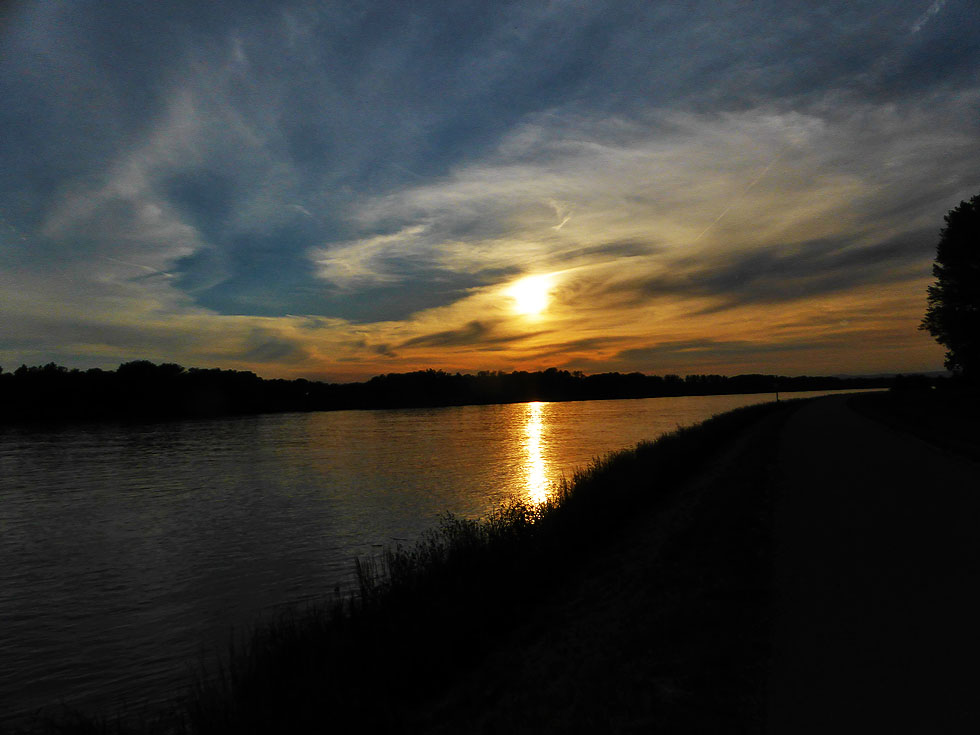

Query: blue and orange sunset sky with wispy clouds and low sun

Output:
[0, 0, 980, 381]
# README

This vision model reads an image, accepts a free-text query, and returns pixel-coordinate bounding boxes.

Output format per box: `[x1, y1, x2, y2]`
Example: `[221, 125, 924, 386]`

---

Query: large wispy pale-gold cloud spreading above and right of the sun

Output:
[340, 96, 978, 322]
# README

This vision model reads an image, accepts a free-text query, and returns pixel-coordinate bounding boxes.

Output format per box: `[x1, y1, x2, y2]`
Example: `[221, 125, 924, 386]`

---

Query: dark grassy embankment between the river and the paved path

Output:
[24, 403, 804, 733]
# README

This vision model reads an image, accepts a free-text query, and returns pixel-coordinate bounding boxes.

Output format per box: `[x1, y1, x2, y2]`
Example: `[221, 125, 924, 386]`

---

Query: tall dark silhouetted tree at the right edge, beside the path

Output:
[919, 194, 980, 379]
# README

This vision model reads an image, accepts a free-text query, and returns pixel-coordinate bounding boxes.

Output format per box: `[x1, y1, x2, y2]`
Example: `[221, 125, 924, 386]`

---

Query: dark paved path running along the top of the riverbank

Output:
[769, 397, 980, 735]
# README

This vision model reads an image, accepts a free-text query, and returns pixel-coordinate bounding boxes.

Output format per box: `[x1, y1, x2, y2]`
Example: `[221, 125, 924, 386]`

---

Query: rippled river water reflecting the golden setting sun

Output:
[0, 393, 856, 722]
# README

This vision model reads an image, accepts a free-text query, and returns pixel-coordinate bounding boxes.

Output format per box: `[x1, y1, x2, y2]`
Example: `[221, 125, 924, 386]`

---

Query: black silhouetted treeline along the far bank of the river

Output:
[0, 360, 908, 422]
